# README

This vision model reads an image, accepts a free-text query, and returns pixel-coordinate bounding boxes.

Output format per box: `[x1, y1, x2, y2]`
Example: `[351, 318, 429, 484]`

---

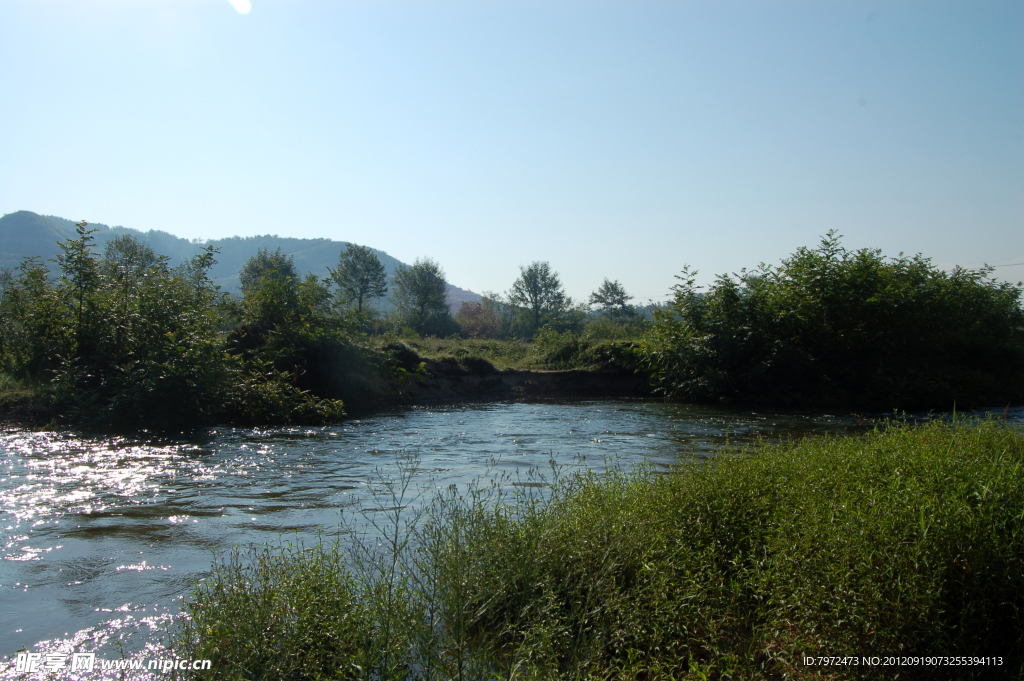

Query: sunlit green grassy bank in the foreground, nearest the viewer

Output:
[173, 422, 1024, 679]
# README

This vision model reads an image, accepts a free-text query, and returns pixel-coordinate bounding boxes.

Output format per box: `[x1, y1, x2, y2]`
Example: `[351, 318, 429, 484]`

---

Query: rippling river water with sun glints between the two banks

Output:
[0, 400, 1007, 678]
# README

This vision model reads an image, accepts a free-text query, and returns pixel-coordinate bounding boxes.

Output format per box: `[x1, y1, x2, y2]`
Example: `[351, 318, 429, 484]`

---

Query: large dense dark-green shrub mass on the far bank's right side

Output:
[644, 232, 1024, 409]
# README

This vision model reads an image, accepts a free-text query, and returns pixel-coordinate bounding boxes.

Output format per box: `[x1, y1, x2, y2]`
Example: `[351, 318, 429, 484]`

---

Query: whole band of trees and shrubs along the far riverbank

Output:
[0, 228, 1024, 430]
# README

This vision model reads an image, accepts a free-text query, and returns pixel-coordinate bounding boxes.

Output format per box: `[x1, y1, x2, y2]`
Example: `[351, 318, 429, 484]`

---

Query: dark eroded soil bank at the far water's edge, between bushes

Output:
[386, 359, 650, 403]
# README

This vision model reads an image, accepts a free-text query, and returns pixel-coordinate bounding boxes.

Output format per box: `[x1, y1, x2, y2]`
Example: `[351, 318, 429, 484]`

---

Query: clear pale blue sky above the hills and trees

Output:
[0, 0, 1024, 299]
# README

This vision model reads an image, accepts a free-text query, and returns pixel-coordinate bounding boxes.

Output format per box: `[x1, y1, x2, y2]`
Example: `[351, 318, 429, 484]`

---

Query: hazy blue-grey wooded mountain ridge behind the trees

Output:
[0, 211, 480, 311]
